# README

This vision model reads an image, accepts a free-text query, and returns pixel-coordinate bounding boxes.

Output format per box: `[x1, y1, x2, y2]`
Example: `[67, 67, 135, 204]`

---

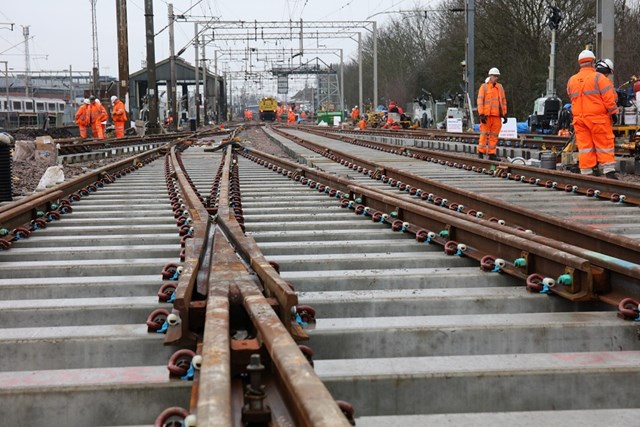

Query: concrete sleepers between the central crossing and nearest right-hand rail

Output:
[234, 148, 639, 425]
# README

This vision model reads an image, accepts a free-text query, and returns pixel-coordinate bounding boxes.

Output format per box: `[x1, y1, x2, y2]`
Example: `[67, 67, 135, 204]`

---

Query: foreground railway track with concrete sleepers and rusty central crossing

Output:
[0, 125, 640, 426]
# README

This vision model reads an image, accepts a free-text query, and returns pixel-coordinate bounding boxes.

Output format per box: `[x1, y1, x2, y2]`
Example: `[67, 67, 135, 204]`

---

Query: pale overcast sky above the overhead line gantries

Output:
[0, 0, 435, 76]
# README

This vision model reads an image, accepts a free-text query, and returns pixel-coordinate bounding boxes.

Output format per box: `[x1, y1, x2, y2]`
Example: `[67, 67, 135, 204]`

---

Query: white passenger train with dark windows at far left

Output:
[0, 94, 66, 129]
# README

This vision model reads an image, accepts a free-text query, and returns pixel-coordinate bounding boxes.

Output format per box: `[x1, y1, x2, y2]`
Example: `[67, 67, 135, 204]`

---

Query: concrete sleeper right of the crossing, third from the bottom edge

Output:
[306, 311, 637, 359]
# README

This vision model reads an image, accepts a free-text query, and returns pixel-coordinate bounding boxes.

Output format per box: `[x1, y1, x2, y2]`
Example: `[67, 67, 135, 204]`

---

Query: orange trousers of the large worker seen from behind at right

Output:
[573, 114, 616, 173]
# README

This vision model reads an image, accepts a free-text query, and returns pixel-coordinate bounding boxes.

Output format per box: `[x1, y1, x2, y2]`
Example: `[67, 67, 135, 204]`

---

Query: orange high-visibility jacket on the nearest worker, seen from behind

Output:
[567, 67, 618, 120]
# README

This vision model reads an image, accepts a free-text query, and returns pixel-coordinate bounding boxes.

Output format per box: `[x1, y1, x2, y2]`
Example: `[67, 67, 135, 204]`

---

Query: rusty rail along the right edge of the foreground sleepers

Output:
[240, 148, 640, 304]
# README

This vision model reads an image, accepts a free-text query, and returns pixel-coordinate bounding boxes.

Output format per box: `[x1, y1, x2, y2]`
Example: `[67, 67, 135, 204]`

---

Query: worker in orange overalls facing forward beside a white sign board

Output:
[477, 67, 507, 160]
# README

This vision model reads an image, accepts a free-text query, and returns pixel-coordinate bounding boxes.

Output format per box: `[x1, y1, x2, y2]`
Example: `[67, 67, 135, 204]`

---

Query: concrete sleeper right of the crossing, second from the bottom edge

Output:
[315, 351, 640, 416]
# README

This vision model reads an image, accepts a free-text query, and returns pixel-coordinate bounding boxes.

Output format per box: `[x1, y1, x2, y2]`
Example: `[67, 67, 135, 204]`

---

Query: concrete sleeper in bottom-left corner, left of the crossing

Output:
[0, 365, 192, 427]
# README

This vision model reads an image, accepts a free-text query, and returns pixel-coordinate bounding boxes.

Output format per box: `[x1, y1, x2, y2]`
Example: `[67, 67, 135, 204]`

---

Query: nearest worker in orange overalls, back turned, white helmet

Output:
[567, 49, 618, 179]
